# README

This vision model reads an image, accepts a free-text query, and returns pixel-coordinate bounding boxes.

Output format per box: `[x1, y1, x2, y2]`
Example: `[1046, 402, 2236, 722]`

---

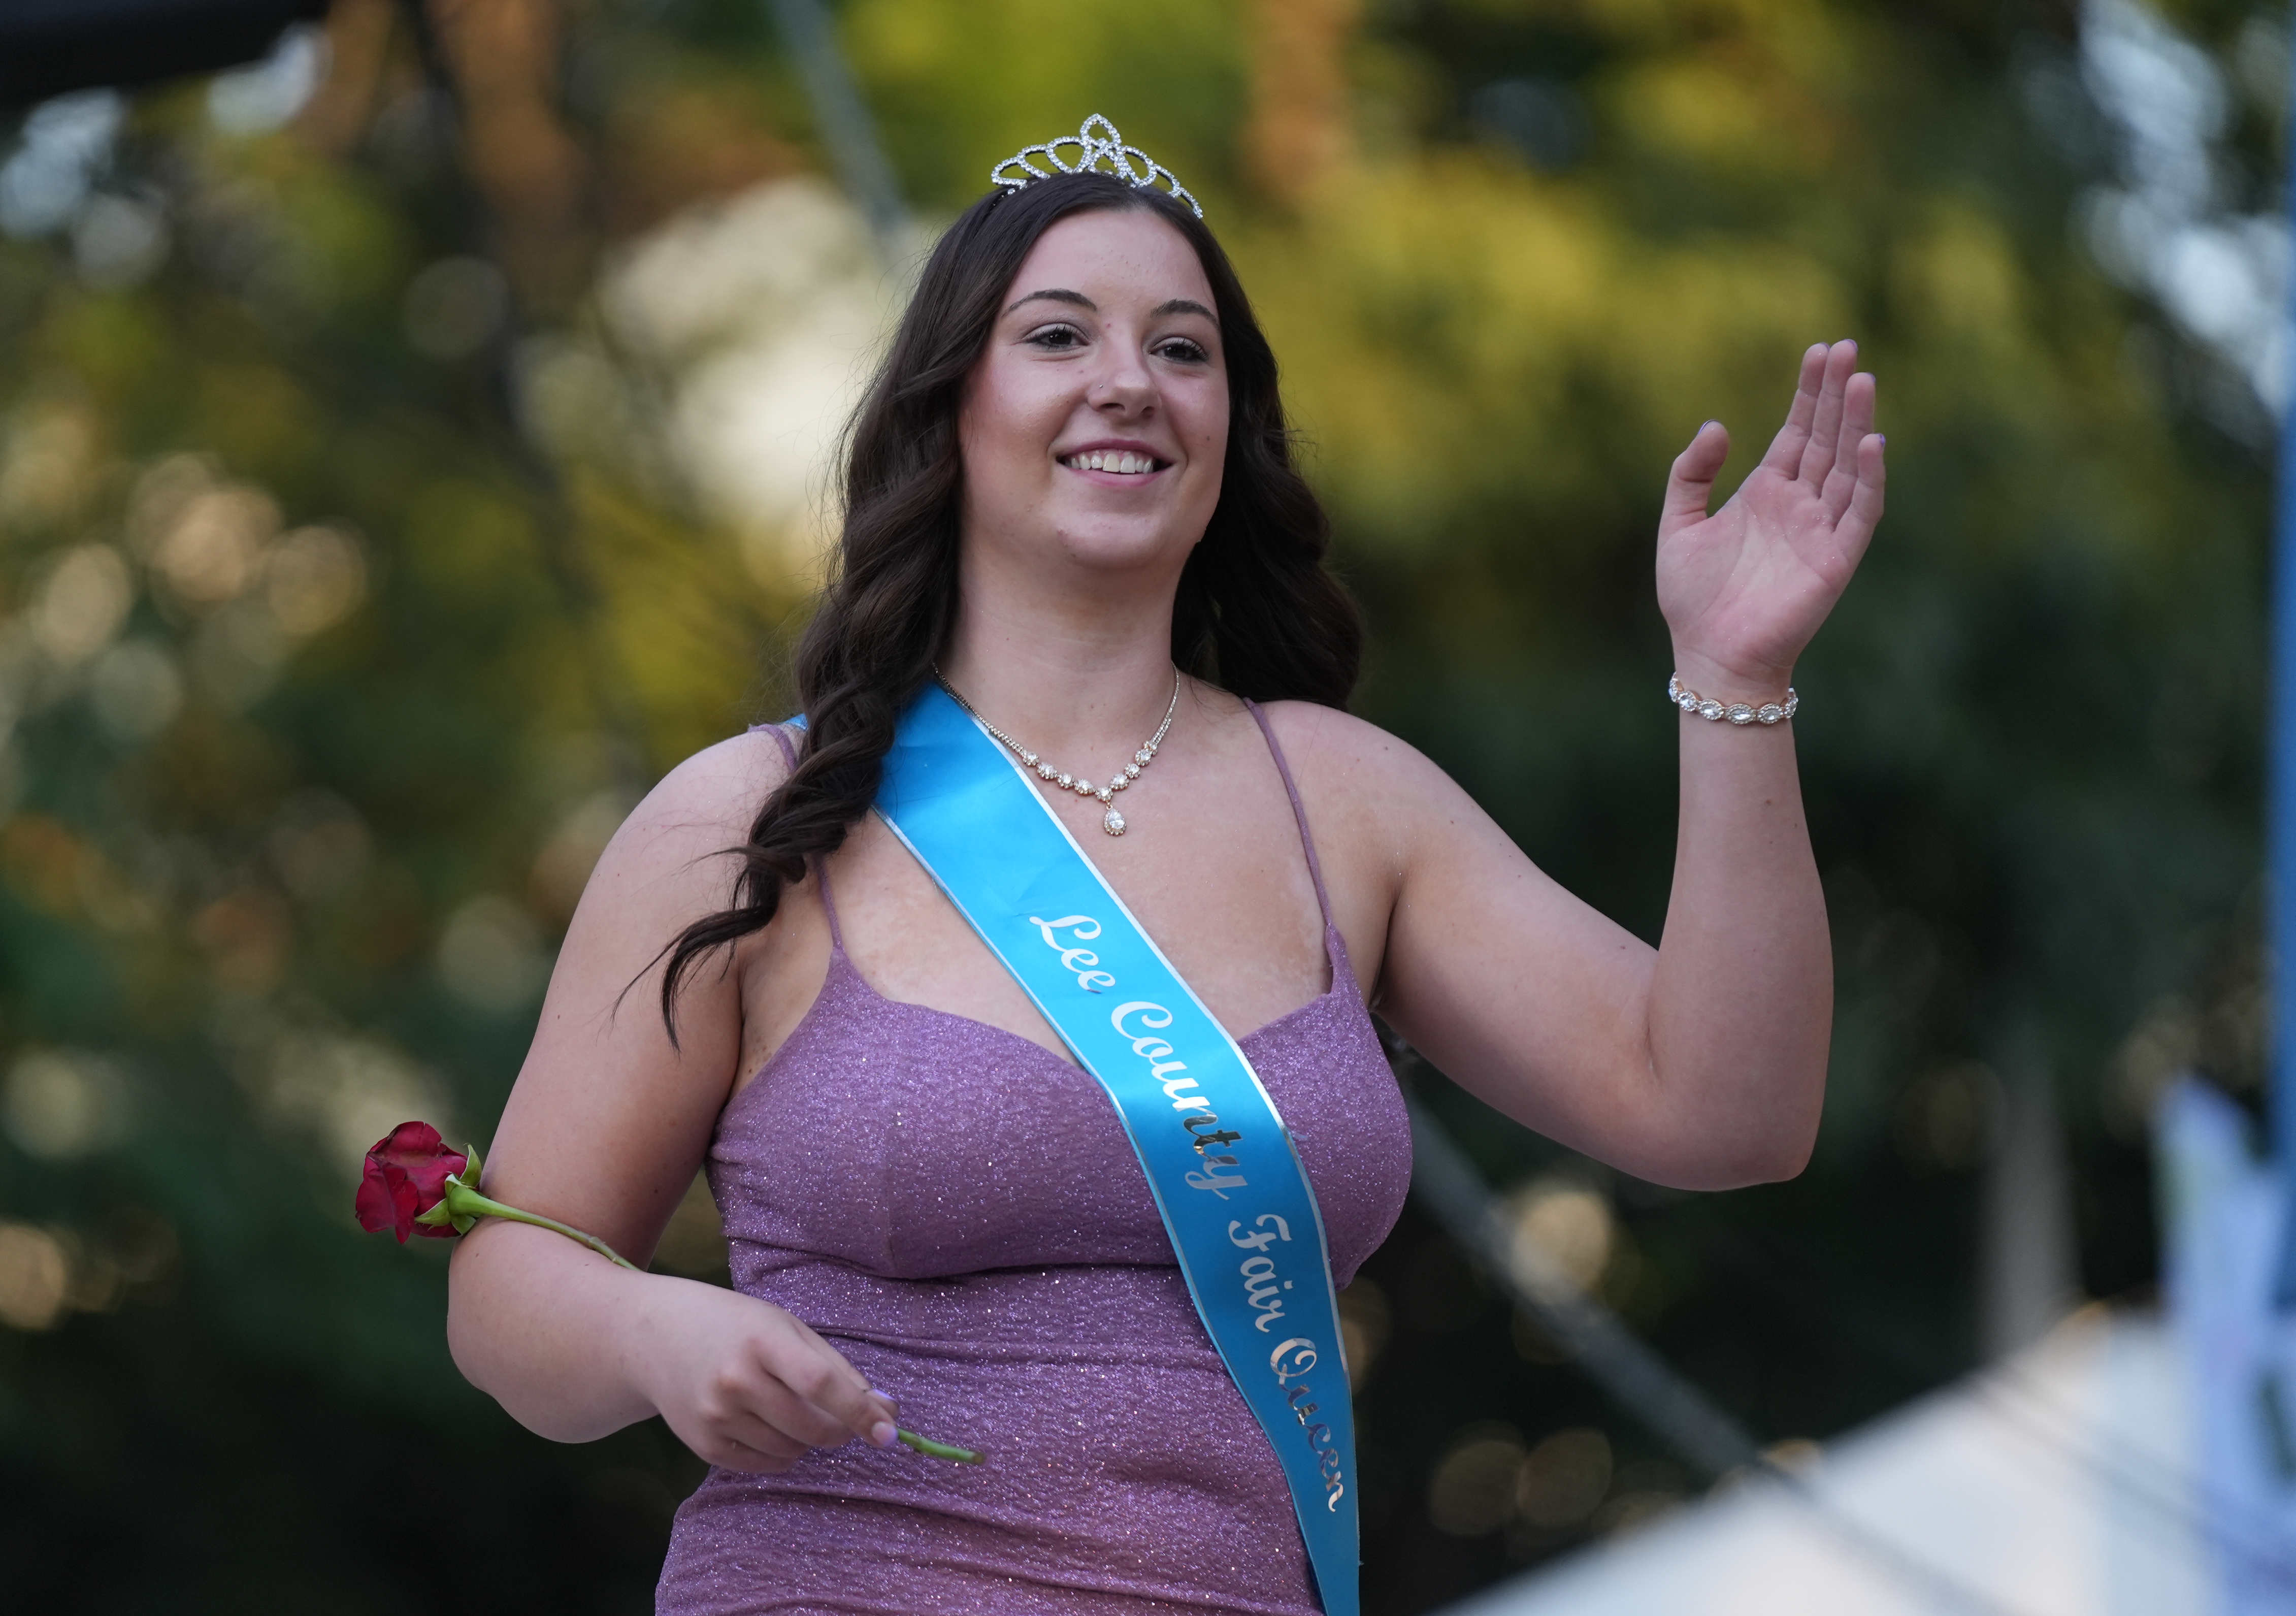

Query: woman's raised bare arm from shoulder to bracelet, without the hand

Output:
[1364, 714, 1832, 1189]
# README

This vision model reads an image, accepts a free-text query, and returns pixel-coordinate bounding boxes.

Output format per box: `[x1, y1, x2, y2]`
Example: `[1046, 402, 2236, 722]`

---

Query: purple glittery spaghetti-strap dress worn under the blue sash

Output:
[657, 707, 1410, 1616]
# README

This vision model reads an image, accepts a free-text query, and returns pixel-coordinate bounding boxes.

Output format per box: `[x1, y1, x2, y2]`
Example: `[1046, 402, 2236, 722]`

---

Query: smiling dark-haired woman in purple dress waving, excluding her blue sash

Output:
[450, 120, 1883, 1616]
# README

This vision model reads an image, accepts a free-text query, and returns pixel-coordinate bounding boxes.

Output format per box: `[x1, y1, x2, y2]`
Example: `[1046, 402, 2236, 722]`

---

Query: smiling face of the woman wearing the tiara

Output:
[958, 211, 1228, 576]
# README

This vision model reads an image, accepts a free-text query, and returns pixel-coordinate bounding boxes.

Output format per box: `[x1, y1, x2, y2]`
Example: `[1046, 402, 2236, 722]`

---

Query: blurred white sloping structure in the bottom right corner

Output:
[1451, 1306, 2213, 1616]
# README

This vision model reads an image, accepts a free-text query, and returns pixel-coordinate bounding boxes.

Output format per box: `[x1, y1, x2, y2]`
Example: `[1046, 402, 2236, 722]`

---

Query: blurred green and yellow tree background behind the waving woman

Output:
[0, 0, 2289, 1616]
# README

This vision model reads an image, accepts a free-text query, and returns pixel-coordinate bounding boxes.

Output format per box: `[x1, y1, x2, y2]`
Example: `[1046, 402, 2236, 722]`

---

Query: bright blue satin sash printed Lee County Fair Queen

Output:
[877, 686, 1359, 1616]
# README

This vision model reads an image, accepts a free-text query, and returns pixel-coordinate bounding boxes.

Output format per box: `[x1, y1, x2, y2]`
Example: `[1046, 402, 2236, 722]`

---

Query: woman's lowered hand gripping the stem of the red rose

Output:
[632, 1276, 896, 1476]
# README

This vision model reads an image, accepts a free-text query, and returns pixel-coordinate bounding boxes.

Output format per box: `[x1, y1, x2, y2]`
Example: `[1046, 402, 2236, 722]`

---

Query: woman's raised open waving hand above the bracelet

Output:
[1658, 342, 1883, 700]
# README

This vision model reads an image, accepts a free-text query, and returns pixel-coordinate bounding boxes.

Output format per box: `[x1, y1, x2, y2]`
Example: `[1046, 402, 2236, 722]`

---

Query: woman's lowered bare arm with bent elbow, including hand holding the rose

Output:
[448, 737, 893, 1469]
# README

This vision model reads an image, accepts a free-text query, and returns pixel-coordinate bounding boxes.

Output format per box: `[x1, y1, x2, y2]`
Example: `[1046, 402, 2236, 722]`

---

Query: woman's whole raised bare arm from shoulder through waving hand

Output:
[1316, 342, 1883, 1189]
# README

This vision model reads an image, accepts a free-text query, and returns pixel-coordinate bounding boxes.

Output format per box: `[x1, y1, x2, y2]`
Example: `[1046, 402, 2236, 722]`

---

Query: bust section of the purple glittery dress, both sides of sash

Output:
[709, 962, 1410, 1279]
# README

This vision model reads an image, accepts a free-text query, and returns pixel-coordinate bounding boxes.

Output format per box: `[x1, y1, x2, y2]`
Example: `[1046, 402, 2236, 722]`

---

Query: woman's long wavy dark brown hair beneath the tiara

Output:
[661, 175, 1364, 1042]
